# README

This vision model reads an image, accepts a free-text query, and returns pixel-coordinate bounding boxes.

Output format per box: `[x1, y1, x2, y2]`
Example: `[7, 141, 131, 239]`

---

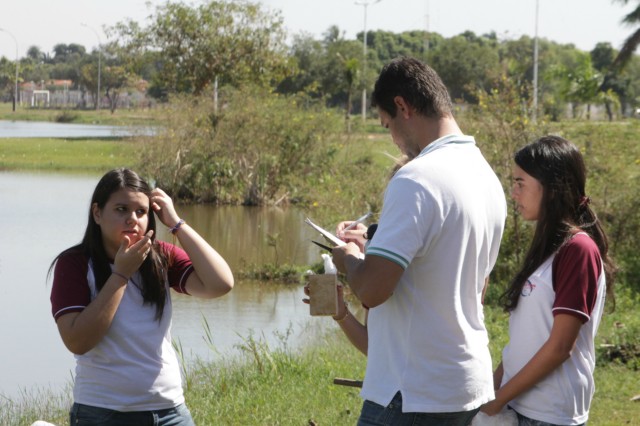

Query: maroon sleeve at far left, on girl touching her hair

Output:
[51, 253, 91, 321]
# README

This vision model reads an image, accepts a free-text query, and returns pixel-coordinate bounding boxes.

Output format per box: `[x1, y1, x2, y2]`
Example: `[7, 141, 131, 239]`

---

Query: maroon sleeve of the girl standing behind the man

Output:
[552, 233, 602, 323]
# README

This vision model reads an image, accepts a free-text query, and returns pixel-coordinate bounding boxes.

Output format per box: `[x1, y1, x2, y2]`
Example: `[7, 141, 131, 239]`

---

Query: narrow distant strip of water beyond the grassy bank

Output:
[0, 120, 153, 138]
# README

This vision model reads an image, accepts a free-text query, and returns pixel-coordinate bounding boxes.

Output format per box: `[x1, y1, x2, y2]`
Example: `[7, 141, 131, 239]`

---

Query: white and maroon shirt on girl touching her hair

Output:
[51, 241, 193, 411]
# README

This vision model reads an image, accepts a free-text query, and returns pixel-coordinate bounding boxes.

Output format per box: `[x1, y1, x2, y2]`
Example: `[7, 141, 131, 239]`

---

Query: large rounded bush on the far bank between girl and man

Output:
[141, 89, 342, 205]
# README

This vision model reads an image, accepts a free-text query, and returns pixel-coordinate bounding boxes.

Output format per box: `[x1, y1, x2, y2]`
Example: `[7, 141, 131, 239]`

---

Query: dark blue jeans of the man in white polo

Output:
[358, 392, 480, 426]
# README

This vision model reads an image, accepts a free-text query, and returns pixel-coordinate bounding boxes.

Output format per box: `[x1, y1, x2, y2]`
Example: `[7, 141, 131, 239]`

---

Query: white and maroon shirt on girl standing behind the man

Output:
[502, 233, 606, 425]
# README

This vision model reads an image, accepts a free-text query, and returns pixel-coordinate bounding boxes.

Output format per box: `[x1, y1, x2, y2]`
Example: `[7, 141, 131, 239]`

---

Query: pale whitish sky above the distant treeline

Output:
[0, 0, 635, 60]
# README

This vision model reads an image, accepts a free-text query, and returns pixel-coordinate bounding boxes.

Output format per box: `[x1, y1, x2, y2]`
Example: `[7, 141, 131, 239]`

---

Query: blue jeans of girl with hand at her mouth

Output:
[69, 403, 195, 426]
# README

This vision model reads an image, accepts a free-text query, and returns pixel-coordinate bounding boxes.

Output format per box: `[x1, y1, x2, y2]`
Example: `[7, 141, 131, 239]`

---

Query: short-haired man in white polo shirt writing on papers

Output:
[333, 58, 506, 426]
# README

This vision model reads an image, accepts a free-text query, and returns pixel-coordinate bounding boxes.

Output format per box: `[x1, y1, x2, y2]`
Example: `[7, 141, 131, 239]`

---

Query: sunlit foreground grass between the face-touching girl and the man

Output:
[186, 328, 365, 425]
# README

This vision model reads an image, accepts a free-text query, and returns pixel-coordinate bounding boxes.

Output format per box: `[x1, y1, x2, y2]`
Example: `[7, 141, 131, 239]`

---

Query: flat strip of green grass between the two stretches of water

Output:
[0, 138, 138, 172]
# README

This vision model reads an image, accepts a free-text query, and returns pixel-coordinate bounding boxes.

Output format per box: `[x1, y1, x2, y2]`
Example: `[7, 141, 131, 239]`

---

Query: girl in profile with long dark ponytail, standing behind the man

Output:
[482, 136, 615, 426]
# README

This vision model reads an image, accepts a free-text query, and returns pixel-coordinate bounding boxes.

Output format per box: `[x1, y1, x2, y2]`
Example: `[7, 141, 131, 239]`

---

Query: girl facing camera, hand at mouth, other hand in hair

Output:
[51, 169, 233, 426]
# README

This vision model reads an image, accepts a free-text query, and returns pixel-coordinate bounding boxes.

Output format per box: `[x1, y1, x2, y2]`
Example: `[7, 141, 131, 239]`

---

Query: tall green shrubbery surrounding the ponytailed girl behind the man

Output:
[461, 75, 640, 303]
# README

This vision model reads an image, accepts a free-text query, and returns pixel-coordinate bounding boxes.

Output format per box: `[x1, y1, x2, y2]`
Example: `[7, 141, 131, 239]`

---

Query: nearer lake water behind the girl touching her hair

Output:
[0, 172, 331, 398]
